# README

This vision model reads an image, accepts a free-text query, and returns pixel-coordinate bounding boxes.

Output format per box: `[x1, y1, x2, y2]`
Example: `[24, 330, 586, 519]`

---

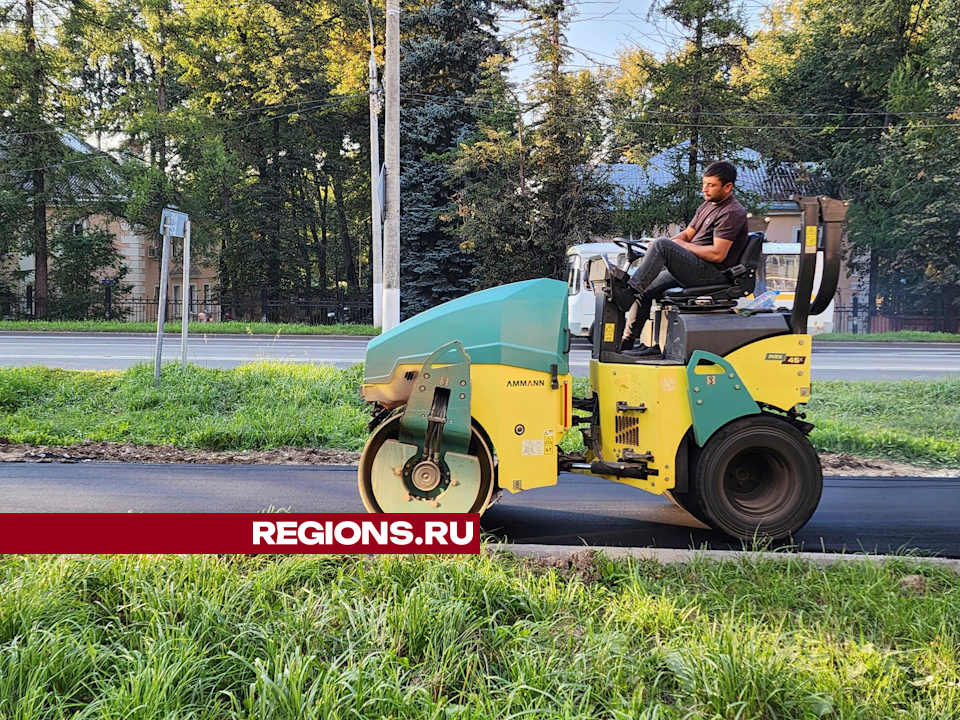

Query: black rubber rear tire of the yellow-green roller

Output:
[680, 413, 823, 541]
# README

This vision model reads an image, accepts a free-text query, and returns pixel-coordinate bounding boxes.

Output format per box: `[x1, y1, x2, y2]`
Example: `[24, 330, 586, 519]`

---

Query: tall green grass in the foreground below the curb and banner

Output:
[0, 553, 960, 720]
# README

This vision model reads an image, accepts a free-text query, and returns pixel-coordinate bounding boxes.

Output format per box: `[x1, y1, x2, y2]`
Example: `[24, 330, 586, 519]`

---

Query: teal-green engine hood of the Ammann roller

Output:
[364, 280, 569, 384]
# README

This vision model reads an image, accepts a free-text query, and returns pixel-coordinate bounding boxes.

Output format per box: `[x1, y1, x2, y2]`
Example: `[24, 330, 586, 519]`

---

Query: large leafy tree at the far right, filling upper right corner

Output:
[752, 0, 960, 326]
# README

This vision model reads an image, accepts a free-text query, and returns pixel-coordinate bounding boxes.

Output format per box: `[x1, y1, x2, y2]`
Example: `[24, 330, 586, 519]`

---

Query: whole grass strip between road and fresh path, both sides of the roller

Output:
[0, 362, 960, 468]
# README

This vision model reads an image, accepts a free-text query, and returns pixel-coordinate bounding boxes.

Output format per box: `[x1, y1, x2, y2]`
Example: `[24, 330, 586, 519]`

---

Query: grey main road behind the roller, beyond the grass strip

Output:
[0, 332, 960, 380]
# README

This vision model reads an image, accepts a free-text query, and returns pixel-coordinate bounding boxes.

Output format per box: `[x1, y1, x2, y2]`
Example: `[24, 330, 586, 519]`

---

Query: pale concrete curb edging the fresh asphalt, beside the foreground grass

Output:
[502, 543, 960, 575]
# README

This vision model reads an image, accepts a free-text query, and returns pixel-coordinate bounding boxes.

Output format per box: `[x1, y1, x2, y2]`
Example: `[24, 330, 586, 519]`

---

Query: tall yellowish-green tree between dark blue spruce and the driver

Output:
[450, 2, 613, 286]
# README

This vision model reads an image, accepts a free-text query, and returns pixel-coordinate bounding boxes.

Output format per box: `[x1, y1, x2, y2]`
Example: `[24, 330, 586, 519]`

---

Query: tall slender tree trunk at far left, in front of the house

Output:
[23, 0, 50, 318]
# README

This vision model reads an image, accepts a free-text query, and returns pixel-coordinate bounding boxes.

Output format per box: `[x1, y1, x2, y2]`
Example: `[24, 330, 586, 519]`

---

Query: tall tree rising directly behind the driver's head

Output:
[611, 0, 749, 232]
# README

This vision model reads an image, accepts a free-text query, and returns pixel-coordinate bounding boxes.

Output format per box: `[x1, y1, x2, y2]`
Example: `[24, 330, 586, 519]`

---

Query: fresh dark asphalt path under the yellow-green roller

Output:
[0, 463, 960, 557]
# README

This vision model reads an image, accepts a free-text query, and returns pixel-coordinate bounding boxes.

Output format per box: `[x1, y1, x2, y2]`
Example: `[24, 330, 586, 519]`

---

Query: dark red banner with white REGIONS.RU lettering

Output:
[0, 513, 480, 555]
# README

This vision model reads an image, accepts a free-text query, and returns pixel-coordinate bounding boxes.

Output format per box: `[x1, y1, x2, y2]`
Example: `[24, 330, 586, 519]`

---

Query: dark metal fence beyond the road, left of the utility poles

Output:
[0, 288, 373, 325]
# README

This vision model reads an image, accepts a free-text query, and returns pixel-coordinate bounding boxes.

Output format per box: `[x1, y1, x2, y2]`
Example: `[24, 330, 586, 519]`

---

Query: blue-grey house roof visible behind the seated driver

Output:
[609, 140, 824, 202]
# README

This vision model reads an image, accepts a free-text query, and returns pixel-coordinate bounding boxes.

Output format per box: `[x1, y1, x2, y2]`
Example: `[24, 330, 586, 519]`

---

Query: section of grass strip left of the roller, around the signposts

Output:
[0, 362, 370, 450]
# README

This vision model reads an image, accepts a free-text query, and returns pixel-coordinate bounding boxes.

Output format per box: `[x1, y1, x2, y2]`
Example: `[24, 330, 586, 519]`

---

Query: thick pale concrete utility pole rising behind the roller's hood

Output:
[383, 0, 400, 330]
